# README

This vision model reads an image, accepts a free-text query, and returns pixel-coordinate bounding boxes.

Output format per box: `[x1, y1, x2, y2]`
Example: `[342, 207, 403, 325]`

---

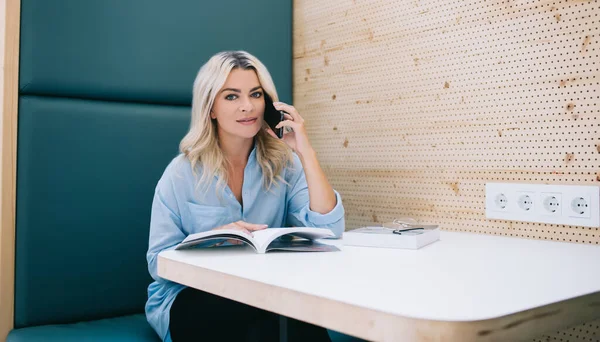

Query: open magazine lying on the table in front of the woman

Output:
[175, 227, 339, 253]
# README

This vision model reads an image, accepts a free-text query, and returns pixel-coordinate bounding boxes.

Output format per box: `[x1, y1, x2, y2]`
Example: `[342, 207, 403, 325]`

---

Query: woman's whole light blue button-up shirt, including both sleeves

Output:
[146, 149, 344, 342]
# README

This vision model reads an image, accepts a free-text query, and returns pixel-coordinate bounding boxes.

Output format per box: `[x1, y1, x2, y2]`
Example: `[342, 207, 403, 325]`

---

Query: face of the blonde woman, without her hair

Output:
[210, 68, 265, 138]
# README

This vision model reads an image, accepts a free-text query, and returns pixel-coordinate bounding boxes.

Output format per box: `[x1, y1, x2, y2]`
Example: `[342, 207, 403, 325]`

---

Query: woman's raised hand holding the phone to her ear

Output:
[268, 102, 312, 156]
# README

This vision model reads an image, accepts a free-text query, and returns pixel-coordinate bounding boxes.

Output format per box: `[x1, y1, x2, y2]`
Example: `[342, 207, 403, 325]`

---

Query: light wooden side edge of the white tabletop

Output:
[158, 254, 600, 342]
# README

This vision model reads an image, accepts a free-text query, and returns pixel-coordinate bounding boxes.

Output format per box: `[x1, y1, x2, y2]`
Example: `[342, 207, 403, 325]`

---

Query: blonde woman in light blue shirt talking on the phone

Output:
[146, 51, 344, 342]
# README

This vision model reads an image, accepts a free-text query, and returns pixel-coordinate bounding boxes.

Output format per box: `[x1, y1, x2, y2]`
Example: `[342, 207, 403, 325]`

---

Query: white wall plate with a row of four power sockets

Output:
[485, 183, 600, 228]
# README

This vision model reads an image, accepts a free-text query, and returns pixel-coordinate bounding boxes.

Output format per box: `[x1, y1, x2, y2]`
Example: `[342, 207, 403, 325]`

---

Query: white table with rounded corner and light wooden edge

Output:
[158, 231, 600, 341]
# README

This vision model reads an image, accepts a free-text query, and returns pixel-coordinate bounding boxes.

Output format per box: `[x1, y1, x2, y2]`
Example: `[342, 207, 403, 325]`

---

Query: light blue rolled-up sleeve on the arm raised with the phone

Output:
[287, 165, 345, 237]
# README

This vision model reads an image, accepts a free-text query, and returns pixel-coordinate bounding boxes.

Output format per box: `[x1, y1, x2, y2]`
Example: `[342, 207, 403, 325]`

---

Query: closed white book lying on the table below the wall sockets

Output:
[343, 227, 440, 249]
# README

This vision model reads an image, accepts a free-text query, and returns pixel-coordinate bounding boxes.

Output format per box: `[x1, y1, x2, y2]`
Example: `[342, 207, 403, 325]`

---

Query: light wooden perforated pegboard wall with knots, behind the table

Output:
[294, 0, 600, 244]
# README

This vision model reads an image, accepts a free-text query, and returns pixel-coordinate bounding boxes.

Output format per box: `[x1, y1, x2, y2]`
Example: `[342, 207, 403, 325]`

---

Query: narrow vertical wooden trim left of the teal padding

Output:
[0, 0, 21, 341]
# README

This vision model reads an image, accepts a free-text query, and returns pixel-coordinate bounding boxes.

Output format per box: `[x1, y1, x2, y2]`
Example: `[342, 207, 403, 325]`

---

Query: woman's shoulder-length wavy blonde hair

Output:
[179, 51, 293, 195]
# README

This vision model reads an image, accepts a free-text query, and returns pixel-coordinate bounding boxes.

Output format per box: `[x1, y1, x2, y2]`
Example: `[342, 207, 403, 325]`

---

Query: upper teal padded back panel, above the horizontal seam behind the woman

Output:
[19, 0, 292, 104]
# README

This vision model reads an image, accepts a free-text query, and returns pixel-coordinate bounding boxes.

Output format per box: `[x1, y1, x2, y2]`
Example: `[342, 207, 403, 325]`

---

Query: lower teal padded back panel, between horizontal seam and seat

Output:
[15, 96, 189, 328]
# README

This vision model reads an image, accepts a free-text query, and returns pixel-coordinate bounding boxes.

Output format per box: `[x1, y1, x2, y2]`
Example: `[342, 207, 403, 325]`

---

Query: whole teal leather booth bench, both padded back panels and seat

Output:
[8, 0, 360, 342]
